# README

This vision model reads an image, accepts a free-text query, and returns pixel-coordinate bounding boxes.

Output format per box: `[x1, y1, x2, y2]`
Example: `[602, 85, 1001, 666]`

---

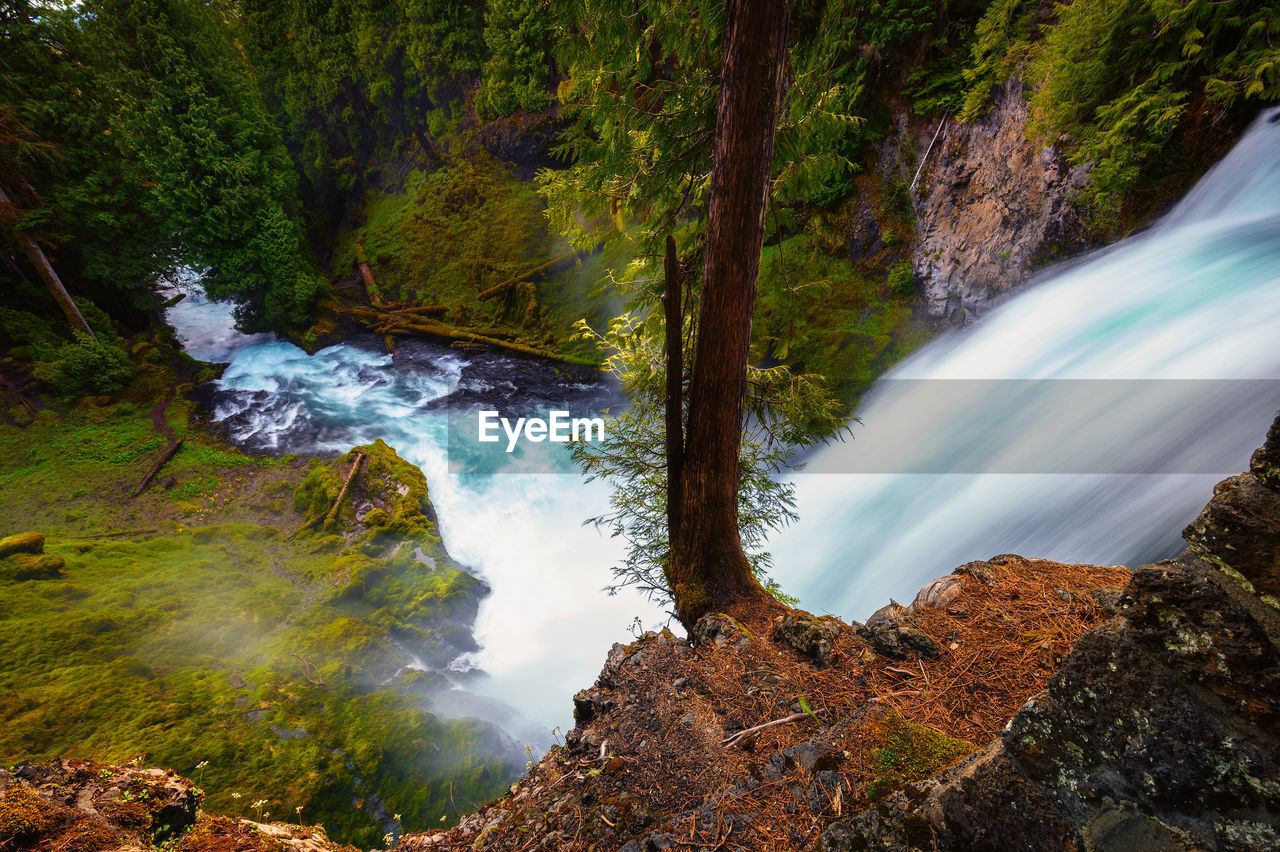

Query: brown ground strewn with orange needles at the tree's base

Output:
[397, 556, 1129, 852]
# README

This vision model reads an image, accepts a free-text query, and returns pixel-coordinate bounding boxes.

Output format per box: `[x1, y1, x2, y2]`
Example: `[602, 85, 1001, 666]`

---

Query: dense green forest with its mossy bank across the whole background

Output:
[0, 0, 1280, 397]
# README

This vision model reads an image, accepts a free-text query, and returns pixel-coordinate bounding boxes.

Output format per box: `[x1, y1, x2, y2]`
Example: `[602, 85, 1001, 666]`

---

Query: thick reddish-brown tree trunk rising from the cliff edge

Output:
[671, 0, 792, 627]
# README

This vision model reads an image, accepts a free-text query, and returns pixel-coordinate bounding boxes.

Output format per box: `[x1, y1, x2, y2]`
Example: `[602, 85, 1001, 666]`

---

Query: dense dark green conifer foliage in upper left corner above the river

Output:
[0, 0, 320, 327]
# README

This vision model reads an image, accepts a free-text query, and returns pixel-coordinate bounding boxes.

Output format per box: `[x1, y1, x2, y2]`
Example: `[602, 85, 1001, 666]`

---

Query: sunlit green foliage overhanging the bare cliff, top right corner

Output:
[964, 0, 1280, 226]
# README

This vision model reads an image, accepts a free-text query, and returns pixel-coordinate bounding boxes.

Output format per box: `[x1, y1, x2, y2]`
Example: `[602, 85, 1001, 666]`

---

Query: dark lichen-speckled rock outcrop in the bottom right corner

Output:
[819, 409, 1280, 852]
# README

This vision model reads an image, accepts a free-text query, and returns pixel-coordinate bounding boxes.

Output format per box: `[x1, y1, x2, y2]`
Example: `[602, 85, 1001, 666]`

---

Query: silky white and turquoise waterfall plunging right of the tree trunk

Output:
[772, 109, 1280, 618]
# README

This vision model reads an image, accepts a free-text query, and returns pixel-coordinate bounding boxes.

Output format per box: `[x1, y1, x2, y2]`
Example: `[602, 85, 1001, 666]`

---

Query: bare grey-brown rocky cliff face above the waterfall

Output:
[896, 78, 1088, 325]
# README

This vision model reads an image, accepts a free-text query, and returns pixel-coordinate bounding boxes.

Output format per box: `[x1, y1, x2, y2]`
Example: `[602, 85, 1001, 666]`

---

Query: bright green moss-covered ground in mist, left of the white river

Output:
[0, 370, 517, 847]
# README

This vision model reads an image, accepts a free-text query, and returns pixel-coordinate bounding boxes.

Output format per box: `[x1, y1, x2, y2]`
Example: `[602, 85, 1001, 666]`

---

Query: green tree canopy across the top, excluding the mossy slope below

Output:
[0, 0, 1280, 329]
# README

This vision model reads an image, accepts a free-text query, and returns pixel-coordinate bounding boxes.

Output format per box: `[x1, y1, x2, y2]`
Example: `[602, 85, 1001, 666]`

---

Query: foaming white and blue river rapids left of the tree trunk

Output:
[169, 290, 666, 745]
